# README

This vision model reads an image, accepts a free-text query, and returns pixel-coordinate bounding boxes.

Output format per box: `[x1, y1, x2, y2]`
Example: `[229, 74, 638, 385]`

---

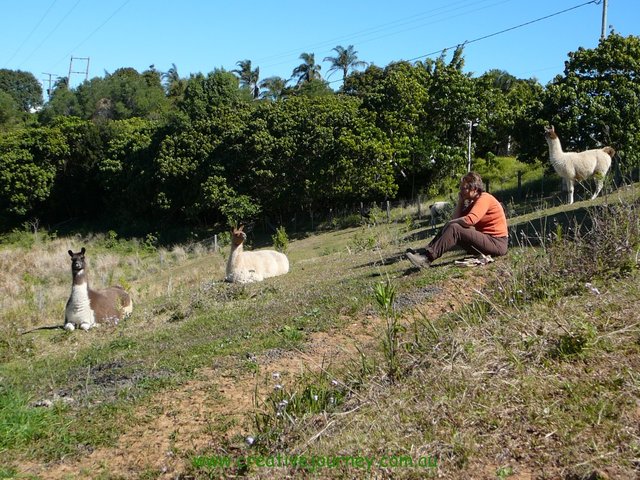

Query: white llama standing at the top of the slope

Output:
[544, 125, 616, 205]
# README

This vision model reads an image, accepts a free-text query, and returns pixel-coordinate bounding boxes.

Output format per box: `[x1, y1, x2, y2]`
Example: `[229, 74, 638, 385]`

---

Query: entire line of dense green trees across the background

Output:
[0, 32, 640, 234]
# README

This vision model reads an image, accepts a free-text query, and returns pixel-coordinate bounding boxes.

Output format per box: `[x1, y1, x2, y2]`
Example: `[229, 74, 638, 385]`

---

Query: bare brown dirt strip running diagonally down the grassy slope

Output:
[21, 276, 478, 480]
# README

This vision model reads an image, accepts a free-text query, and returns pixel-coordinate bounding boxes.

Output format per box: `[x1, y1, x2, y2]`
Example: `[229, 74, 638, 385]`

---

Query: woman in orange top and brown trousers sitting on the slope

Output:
[407, 172, 509, 268]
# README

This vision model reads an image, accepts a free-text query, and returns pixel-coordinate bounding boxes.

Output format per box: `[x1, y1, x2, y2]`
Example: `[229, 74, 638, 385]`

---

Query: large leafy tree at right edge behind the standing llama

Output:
[516, 32, 640, 173]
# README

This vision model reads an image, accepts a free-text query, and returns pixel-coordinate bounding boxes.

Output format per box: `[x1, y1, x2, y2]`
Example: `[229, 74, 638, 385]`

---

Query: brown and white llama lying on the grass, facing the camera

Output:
[64, 247, 133, 331]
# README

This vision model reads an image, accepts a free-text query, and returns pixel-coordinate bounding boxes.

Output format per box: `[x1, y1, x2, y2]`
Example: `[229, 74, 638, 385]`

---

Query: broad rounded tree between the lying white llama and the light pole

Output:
[238, 95, 396, 214]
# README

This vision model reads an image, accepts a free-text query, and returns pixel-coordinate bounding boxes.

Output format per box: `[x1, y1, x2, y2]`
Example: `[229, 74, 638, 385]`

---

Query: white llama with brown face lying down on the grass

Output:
[225, 226, 289, 283]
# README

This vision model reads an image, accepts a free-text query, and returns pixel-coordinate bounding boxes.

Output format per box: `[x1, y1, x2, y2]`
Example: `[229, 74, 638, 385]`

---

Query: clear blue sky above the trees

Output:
[0, 0, 640, 94]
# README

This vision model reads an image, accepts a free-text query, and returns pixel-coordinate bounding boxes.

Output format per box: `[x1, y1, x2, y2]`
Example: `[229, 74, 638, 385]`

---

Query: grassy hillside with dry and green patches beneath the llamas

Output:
[0, 182, 640, 478]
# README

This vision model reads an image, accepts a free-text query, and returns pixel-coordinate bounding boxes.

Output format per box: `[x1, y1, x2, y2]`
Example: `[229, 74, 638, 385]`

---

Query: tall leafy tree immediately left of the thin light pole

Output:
[343, 48, 480, 196]
